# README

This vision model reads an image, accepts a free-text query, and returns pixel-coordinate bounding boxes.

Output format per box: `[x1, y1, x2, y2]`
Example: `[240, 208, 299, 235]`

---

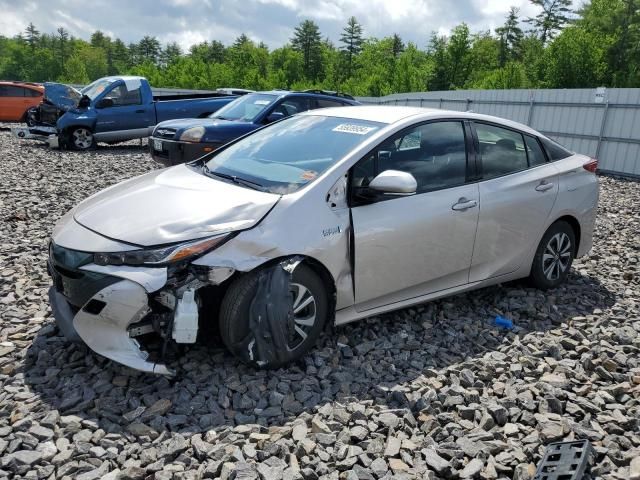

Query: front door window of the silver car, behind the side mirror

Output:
[352, 121, 467, 193]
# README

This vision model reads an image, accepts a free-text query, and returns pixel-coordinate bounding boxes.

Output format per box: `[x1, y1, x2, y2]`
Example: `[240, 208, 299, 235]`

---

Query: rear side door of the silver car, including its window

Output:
[469, 122, 558, 282]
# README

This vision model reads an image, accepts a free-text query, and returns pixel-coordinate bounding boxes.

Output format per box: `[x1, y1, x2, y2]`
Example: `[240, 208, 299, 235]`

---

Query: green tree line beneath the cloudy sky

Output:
[0, 0, 640, 96]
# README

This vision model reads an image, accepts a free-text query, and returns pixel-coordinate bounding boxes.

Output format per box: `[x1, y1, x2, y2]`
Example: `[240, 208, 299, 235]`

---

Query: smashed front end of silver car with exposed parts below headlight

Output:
[48, 236, 234, 375]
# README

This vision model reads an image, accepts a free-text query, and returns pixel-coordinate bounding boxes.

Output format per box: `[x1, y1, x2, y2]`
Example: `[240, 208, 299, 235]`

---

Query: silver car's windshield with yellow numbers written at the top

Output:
[206, 115, 384, 194]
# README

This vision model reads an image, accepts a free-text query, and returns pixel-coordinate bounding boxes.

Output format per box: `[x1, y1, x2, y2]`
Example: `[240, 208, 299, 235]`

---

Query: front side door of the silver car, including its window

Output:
[351, 121, 480, 311]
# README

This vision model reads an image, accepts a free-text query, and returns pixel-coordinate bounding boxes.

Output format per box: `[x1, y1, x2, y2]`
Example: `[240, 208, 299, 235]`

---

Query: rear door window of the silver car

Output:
[475, 123, 528, 180]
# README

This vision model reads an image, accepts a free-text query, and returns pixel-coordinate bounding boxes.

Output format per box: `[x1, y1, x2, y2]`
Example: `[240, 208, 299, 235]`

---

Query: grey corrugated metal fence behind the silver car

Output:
[358, 88, 640, 177]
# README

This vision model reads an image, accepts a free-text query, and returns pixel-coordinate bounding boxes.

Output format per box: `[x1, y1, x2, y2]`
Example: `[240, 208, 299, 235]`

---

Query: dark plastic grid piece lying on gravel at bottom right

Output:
[533, 440, 595, 480]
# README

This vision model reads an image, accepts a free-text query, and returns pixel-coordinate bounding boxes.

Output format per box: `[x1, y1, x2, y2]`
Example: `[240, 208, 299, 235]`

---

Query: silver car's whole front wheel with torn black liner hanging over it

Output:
[220, 264, 328, 367]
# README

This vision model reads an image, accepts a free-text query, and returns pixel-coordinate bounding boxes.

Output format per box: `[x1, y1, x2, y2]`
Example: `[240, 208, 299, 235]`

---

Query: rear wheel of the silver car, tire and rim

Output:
[529, 221, 576, 290]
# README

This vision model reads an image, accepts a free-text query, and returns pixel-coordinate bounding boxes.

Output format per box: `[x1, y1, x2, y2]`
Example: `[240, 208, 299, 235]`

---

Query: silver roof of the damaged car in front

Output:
[302, 105, 540, 135]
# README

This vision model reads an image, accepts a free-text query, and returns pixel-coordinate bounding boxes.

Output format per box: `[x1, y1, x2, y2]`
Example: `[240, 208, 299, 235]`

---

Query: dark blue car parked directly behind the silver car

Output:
[149, 90, 359, 166]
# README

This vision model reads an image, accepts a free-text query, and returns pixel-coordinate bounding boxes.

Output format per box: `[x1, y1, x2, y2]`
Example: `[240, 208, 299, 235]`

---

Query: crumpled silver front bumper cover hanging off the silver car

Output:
[49, 266, 173, 375]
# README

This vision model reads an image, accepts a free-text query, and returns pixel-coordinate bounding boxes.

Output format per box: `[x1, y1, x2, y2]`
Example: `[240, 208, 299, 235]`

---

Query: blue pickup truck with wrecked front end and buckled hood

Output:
[13, 76, 237, 150]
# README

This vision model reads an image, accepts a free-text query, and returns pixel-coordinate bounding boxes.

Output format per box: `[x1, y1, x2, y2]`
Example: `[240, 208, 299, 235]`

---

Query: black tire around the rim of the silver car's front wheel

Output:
[219, 264, 328, 368]
